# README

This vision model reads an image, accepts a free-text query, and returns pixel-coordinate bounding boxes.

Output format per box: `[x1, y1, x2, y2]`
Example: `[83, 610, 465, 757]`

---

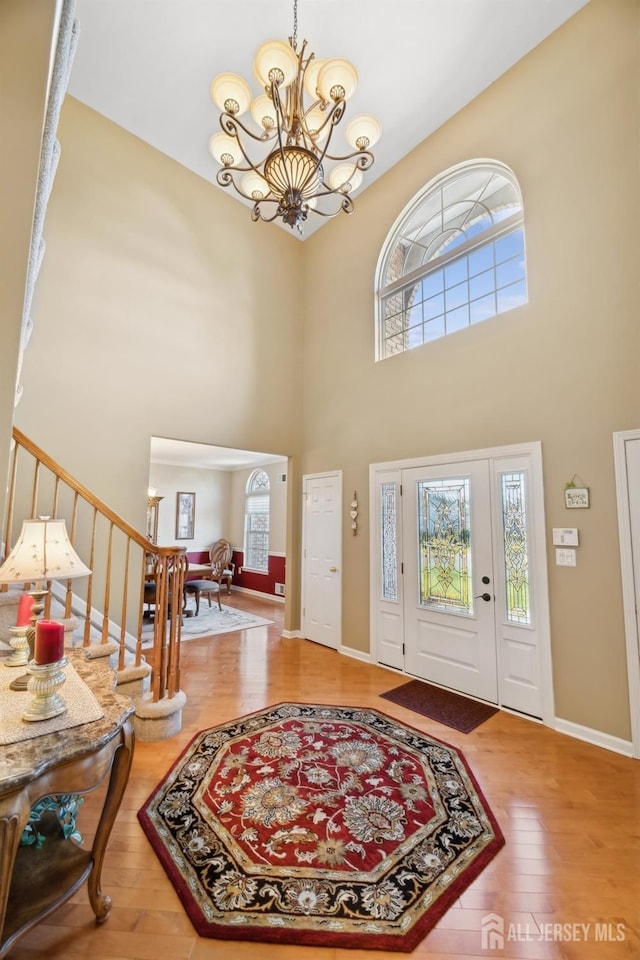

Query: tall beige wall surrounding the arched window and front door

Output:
[303, 0, 640, 738]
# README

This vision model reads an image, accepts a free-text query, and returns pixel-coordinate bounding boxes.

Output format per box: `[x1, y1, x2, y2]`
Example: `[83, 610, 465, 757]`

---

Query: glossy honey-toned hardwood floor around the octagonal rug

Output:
[10, 592, 640, 960]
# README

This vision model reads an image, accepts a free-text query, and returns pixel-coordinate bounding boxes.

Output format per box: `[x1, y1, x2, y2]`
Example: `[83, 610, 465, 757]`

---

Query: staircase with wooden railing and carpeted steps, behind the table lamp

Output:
[0, 427, 187, 740]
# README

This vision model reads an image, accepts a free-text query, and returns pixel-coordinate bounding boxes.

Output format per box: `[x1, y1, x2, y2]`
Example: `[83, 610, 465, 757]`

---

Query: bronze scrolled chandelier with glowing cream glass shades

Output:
[209, 0, 382, 233]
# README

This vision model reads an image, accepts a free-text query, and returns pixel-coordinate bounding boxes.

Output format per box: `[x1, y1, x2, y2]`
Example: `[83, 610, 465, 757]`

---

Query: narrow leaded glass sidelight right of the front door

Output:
[502, 473, 531, 624]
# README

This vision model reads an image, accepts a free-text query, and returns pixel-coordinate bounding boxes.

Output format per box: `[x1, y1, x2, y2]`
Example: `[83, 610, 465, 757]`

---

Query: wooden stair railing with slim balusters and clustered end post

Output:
[0, 427, 186, 702]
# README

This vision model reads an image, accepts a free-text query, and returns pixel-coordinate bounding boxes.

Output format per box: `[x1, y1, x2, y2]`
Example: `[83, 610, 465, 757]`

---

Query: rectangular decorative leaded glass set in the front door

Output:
[418, 478, 473, 614]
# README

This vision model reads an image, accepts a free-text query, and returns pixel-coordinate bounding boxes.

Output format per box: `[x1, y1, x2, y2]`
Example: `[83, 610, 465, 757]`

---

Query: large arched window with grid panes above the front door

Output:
[376, 160, 527, 360]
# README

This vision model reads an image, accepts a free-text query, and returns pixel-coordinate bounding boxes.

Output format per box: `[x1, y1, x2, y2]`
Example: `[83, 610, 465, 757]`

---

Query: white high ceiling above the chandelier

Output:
[69, 0, 588, 236]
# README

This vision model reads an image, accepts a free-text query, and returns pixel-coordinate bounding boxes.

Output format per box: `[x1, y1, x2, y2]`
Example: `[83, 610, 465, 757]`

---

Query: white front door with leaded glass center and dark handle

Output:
[402, 460, 498, 703]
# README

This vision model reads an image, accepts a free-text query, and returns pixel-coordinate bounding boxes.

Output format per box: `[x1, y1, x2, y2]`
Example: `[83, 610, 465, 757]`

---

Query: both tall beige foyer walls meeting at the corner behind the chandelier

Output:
[6, 0, 640, 738]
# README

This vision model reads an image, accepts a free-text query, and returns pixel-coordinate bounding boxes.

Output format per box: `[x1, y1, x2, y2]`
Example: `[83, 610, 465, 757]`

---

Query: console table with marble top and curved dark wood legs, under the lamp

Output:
[0, 650, 134, 958]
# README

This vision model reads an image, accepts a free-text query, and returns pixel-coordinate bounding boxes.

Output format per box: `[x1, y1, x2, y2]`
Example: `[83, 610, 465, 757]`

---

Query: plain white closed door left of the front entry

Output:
[302, 473, 342, 650]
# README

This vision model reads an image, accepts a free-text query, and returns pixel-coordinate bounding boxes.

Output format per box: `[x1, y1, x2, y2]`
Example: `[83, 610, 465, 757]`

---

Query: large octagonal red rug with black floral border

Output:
[138, 703, 504, 952]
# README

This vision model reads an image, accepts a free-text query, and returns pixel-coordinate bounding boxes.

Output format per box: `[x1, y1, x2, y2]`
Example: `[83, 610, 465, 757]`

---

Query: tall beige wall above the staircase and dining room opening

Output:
[16, 97, 302, 624]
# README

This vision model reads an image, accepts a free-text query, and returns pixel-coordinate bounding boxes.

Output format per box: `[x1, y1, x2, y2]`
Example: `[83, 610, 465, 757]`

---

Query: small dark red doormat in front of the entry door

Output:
[380, 680, 498, 733]
